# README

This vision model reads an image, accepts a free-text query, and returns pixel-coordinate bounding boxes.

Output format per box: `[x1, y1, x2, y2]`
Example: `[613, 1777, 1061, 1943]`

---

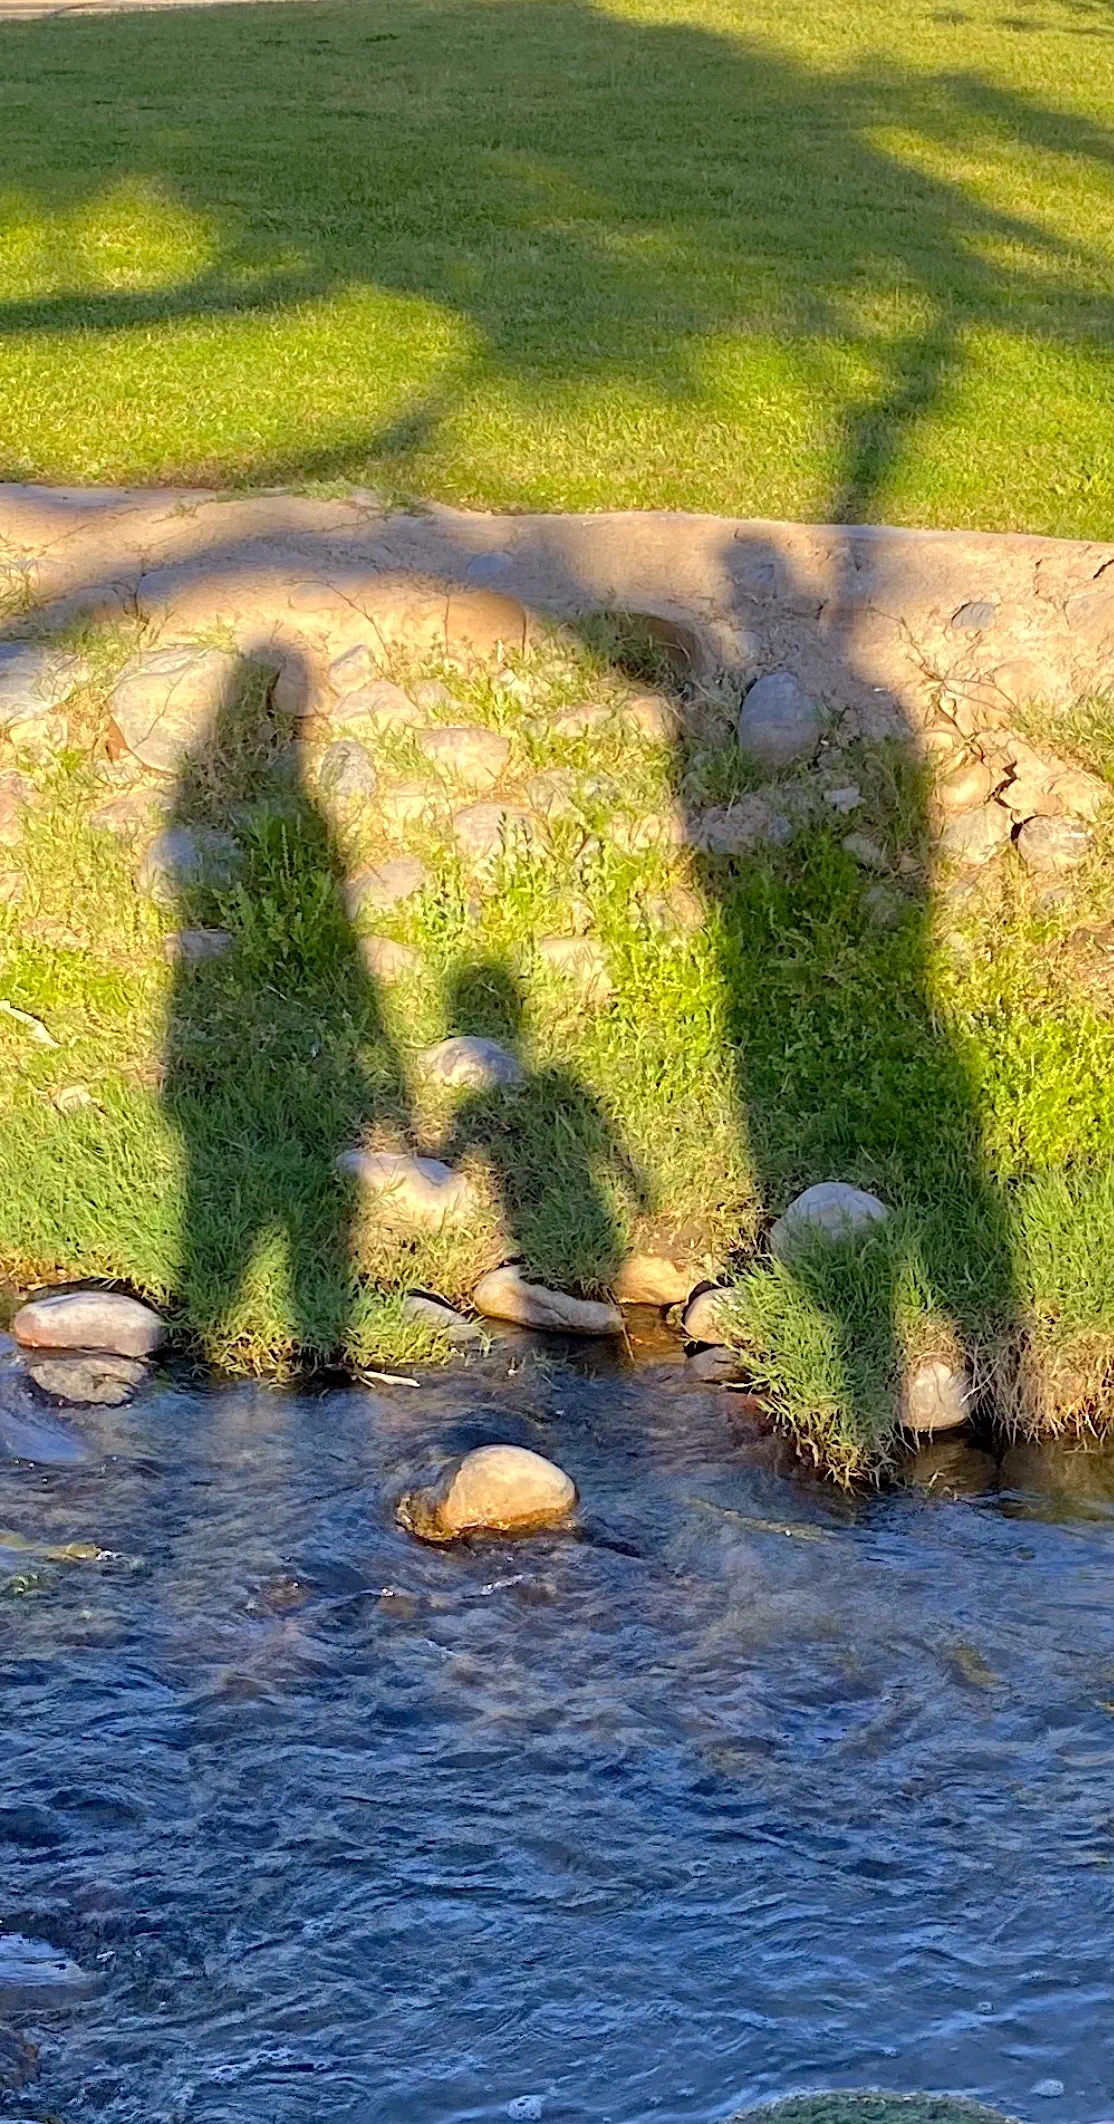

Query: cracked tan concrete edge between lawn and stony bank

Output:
[0, 484, 1114, 735]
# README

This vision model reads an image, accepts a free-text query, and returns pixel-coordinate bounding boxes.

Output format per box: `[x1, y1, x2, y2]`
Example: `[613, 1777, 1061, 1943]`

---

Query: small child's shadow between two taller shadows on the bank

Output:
[444, 960, 653, 1294]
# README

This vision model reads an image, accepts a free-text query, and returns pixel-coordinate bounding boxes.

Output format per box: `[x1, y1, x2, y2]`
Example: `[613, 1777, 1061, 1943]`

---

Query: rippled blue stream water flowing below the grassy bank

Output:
[0, 1353, 1114, 2124]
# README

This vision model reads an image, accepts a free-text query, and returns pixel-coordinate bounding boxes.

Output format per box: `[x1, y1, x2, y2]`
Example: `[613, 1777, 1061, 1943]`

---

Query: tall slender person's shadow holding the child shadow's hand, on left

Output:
[164, 648, 406, 1366]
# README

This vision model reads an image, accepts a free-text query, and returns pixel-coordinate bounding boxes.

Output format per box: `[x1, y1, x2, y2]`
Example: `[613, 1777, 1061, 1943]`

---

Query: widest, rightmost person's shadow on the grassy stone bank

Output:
[651, 543, 1018, 1474]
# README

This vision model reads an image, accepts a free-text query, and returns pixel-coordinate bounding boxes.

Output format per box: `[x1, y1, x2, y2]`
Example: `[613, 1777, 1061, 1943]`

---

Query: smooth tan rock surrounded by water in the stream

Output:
[398, 1446, 576, 1542]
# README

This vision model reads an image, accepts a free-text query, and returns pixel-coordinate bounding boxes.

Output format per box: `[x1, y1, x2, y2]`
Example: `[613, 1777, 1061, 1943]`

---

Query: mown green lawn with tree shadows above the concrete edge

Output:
[0, 0, 1114, 537]
